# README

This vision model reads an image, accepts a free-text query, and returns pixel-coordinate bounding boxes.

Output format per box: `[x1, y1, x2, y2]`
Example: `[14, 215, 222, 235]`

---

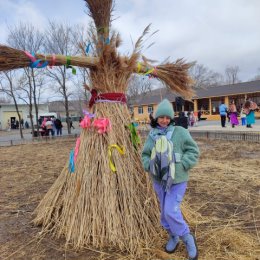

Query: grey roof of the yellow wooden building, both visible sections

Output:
[131, 80, 260, 106]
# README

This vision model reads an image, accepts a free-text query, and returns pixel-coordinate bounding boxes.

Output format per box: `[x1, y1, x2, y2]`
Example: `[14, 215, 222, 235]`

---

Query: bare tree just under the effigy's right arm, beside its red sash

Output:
[127, 75, 152, 105]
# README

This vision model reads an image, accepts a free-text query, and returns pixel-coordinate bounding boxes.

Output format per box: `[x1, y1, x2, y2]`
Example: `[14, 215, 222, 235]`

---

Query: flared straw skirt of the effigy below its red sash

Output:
[34, 103, 159, 254]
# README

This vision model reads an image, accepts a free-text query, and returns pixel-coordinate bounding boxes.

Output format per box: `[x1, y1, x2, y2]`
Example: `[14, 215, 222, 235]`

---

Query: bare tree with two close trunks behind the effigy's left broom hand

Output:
[8, 23, 44, 134]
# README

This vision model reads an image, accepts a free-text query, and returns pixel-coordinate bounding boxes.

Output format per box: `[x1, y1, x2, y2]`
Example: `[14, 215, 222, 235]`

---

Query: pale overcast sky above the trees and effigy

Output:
[0, 0, 260, 81]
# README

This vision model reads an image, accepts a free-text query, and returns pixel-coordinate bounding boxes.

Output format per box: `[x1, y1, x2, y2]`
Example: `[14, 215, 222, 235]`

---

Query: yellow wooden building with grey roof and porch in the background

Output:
[130, 80, 260, 122]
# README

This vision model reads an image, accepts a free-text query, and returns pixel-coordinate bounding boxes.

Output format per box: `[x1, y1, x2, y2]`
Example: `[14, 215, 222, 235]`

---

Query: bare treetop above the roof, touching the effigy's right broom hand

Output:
[190, 64, 223, 89]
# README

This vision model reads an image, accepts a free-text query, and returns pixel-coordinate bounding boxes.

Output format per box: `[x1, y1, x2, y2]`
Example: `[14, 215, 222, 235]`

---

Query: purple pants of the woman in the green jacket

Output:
[154, 182, 190, 236]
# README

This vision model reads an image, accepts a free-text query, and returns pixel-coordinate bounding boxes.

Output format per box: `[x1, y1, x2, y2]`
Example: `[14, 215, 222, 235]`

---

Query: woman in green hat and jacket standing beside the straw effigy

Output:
[142, 99, 199, 260]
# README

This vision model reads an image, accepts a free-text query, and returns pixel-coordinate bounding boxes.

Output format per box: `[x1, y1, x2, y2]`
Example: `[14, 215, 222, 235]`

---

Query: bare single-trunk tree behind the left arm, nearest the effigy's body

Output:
[44, 21, 78, 134]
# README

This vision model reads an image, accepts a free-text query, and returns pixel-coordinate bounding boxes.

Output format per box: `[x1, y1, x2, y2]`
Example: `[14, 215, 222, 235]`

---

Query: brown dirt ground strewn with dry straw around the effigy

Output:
[0, 139, 260, 260]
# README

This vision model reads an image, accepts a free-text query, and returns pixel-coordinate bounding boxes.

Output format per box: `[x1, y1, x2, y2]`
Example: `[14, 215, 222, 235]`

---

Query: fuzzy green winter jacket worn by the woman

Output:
[142, 125, 199, 183]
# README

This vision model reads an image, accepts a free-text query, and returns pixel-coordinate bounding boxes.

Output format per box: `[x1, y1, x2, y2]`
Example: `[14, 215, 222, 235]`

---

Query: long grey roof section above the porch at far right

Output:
[194, 80, 260, 99]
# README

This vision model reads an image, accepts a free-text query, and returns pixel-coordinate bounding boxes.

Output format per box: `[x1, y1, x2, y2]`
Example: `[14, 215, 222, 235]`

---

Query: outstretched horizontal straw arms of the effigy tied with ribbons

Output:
[0, 44, 193, 98]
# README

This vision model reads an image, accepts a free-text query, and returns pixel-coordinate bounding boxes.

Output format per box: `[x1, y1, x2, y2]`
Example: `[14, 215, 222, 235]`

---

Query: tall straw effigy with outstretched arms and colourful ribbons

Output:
[0, 0, 193, 255]
